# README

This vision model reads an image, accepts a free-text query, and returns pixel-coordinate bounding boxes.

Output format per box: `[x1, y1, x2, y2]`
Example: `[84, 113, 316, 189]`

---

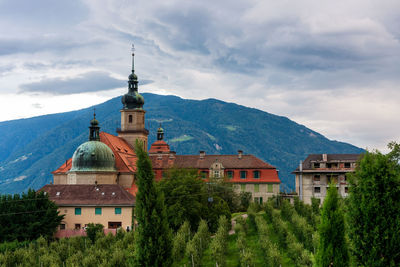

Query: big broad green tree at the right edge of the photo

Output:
[348, 149, 400, 266]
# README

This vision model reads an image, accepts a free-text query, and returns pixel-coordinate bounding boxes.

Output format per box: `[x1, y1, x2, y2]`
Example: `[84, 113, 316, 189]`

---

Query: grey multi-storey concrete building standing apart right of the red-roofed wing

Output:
[292, 154, 361, 204]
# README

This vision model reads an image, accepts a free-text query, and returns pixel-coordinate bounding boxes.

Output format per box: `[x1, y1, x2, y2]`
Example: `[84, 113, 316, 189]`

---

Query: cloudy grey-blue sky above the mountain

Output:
[0, 0, 400, 150]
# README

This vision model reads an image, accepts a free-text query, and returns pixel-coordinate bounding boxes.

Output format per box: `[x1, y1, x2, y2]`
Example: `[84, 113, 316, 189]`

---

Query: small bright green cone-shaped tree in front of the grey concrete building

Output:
[316, 184, 349, 267]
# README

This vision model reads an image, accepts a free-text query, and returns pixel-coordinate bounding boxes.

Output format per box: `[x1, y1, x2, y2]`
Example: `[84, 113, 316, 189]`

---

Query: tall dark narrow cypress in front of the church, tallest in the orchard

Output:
[135, 141, 172, 266]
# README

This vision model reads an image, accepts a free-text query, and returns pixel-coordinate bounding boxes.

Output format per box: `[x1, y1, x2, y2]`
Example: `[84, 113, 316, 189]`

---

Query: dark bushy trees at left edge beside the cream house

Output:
[0, 189, 64, 242]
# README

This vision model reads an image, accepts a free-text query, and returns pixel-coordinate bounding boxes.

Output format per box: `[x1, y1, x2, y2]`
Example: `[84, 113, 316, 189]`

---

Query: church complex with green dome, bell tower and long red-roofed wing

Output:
[43, 49, 280, 232]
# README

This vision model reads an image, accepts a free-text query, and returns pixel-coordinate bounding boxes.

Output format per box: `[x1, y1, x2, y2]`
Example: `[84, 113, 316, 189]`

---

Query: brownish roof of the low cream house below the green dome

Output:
[39, 184, 136, 206]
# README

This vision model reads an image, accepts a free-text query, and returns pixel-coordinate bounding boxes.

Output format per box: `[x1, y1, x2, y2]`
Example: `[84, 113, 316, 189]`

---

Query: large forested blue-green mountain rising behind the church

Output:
[0, 93, 364, 193]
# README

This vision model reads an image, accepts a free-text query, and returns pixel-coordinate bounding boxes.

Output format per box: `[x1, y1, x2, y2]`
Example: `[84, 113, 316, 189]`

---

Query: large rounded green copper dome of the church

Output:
[71, 141, 116, 172]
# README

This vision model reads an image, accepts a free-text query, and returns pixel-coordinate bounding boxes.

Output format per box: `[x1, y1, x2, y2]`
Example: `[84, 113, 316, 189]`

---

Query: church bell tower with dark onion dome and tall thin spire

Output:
[117, 45, 149, 151]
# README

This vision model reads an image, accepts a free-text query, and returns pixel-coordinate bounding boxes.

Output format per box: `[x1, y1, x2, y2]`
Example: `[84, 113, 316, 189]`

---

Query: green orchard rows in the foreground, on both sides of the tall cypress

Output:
[0, 199, 319, 267]
